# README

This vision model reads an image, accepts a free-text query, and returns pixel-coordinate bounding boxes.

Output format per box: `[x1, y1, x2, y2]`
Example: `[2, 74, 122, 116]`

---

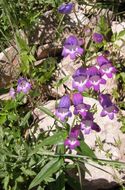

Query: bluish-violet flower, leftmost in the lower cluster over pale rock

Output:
[55, 95, 72, 121]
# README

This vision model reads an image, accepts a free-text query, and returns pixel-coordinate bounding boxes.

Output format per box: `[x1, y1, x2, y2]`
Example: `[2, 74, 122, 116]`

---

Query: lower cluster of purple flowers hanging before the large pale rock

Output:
[55, 93, 100, 149]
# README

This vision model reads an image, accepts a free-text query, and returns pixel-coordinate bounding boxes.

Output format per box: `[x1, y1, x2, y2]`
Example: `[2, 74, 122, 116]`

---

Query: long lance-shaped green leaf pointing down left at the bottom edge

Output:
[29, 158, 63, 189]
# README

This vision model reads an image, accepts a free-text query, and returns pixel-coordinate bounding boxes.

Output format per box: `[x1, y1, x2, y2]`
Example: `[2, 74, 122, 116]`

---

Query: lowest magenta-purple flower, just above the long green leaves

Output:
[64, 125, 80, 150]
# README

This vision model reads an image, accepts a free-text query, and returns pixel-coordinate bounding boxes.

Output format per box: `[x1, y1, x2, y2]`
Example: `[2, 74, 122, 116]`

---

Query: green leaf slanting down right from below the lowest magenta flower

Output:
[78, 141, 96, 158]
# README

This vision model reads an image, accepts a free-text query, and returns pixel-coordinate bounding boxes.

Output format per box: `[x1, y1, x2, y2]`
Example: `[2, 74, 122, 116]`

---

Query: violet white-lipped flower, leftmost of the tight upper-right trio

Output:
[72, 67, 88, 92]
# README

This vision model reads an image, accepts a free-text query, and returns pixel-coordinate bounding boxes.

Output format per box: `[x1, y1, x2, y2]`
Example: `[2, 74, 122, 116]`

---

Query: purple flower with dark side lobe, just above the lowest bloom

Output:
[81, 112, 101, 134]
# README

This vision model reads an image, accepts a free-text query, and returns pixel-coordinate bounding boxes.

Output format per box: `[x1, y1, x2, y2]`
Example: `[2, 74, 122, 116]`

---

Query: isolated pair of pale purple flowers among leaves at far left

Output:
[9, 78, 31, 98]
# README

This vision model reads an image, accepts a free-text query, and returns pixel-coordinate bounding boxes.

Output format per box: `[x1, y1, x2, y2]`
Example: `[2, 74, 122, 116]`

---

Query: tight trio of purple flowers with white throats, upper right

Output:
[72, 55, 116, 92]
